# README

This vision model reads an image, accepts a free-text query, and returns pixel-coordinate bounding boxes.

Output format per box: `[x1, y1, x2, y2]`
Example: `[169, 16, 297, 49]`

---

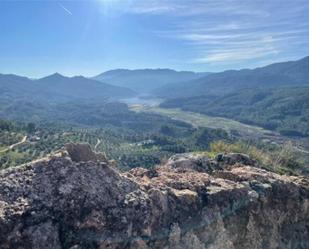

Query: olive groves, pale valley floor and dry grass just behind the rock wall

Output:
[0, 98, 308, 174]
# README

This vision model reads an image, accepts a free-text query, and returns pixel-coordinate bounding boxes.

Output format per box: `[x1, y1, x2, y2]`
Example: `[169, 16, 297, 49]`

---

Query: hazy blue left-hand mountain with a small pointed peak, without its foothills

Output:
[0, 73, 136, 102]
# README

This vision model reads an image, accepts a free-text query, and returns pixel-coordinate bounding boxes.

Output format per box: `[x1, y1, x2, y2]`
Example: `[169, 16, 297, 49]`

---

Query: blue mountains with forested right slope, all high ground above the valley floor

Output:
[0, 57, 309, 130]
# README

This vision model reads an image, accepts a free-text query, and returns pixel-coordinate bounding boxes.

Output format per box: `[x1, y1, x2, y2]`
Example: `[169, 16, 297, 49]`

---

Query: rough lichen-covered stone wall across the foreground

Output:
[0, 145, 309, 249]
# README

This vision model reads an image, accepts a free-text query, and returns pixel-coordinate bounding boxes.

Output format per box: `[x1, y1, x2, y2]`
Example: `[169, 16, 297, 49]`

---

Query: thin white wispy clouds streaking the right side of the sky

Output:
[100, 0, 309, 66]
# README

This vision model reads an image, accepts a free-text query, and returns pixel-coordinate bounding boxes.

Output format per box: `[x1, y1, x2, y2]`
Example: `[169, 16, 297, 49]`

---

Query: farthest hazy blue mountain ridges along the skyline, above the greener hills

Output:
[0, 56, 309, 102]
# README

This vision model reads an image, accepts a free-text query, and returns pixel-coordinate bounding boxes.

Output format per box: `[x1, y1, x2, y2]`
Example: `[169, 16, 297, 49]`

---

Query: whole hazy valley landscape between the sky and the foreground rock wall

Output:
[0, 55, 309, 174]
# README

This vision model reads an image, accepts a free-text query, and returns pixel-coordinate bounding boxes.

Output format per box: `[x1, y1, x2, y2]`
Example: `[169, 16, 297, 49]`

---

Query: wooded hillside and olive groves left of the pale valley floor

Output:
[0, 101, 230, 168]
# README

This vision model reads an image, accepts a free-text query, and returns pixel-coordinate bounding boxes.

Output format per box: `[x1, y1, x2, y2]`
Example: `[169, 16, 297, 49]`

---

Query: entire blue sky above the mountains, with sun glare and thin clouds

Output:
[0, 0, 309, 78]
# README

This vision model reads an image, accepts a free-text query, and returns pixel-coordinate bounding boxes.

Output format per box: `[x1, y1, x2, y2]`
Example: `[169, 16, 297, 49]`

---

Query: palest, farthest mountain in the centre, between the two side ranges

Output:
[92, 69, 208, 93]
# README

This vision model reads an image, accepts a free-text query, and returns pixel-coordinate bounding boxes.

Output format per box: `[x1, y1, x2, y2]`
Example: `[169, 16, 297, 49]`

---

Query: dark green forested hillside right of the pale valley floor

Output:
[161, 87, 309, 136]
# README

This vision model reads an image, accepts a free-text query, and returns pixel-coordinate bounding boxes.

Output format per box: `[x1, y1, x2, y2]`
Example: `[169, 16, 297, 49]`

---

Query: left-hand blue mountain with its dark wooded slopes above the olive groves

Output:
[0, 73, 136, 122]
